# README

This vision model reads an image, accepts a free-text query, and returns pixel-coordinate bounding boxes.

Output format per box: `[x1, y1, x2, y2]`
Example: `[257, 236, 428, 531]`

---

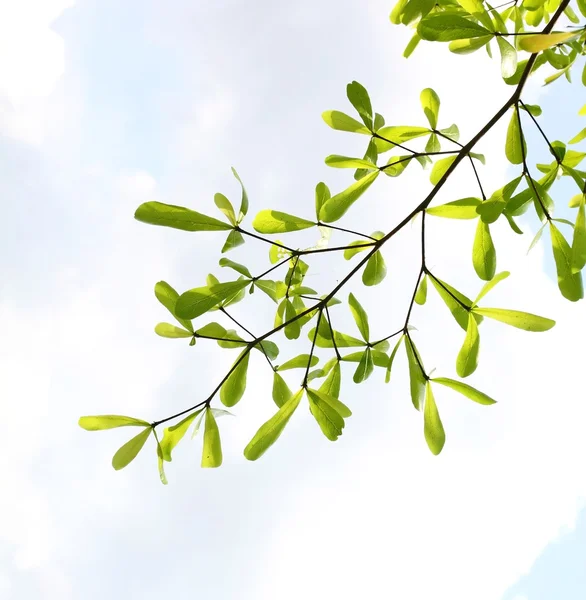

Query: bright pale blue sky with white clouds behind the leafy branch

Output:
[0, 0, 586, 600]
